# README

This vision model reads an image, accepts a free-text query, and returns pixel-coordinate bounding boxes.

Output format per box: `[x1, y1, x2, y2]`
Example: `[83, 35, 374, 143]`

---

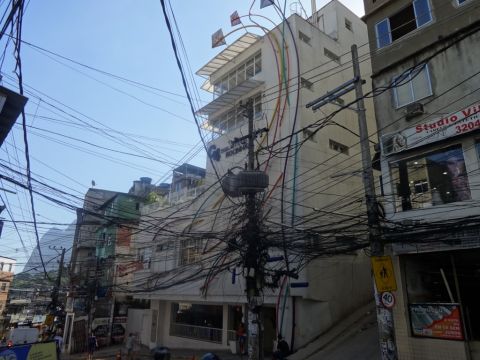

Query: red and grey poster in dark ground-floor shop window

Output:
[409, 303, 463, 340]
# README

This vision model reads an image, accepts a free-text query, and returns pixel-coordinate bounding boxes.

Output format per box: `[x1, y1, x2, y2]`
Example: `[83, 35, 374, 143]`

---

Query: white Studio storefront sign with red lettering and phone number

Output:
[381, 104, 480, 155]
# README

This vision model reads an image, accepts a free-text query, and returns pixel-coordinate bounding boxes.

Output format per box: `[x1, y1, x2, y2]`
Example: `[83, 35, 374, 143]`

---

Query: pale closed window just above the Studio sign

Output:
[393, 64, 433, 109]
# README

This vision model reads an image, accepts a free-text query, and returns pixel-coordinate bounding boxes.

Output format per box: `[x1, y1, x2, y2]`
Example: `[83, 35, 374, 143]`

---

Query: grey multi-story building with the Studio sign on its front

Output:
[364, 0, 480, 360]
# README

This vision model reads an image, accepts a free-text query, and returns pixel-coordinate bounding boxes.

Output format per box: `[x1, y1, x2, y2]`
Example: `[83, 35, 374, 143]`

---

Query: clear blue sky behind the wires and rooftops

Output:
[0, 0, 364, 272]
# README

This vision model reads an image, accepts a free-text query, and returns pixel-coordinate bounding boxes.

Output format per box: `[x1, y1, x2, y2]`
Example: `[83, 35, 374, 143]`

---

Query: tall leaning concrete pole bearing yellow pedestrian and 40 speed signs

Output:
[351, 44, 398, 360]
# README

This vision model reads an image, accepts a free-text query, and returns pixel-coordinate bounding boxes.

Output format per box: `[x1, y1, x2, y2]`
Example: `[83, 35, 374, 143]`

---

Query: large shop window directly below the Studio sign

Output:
[390, 145, 471, 211]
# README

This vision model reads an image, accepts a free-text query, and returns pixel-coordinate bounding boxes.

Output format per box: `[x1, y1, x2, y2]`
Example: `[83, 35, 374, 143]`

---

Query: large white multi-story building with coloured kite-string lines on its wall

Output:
[134, 0, 375, 352]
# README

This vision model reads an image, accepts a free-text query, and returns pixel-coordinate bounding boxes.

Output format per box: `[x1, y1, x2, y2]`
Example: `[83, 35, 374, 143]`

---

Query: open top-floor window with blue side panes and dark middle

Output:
[375, 0, 432, 49]
